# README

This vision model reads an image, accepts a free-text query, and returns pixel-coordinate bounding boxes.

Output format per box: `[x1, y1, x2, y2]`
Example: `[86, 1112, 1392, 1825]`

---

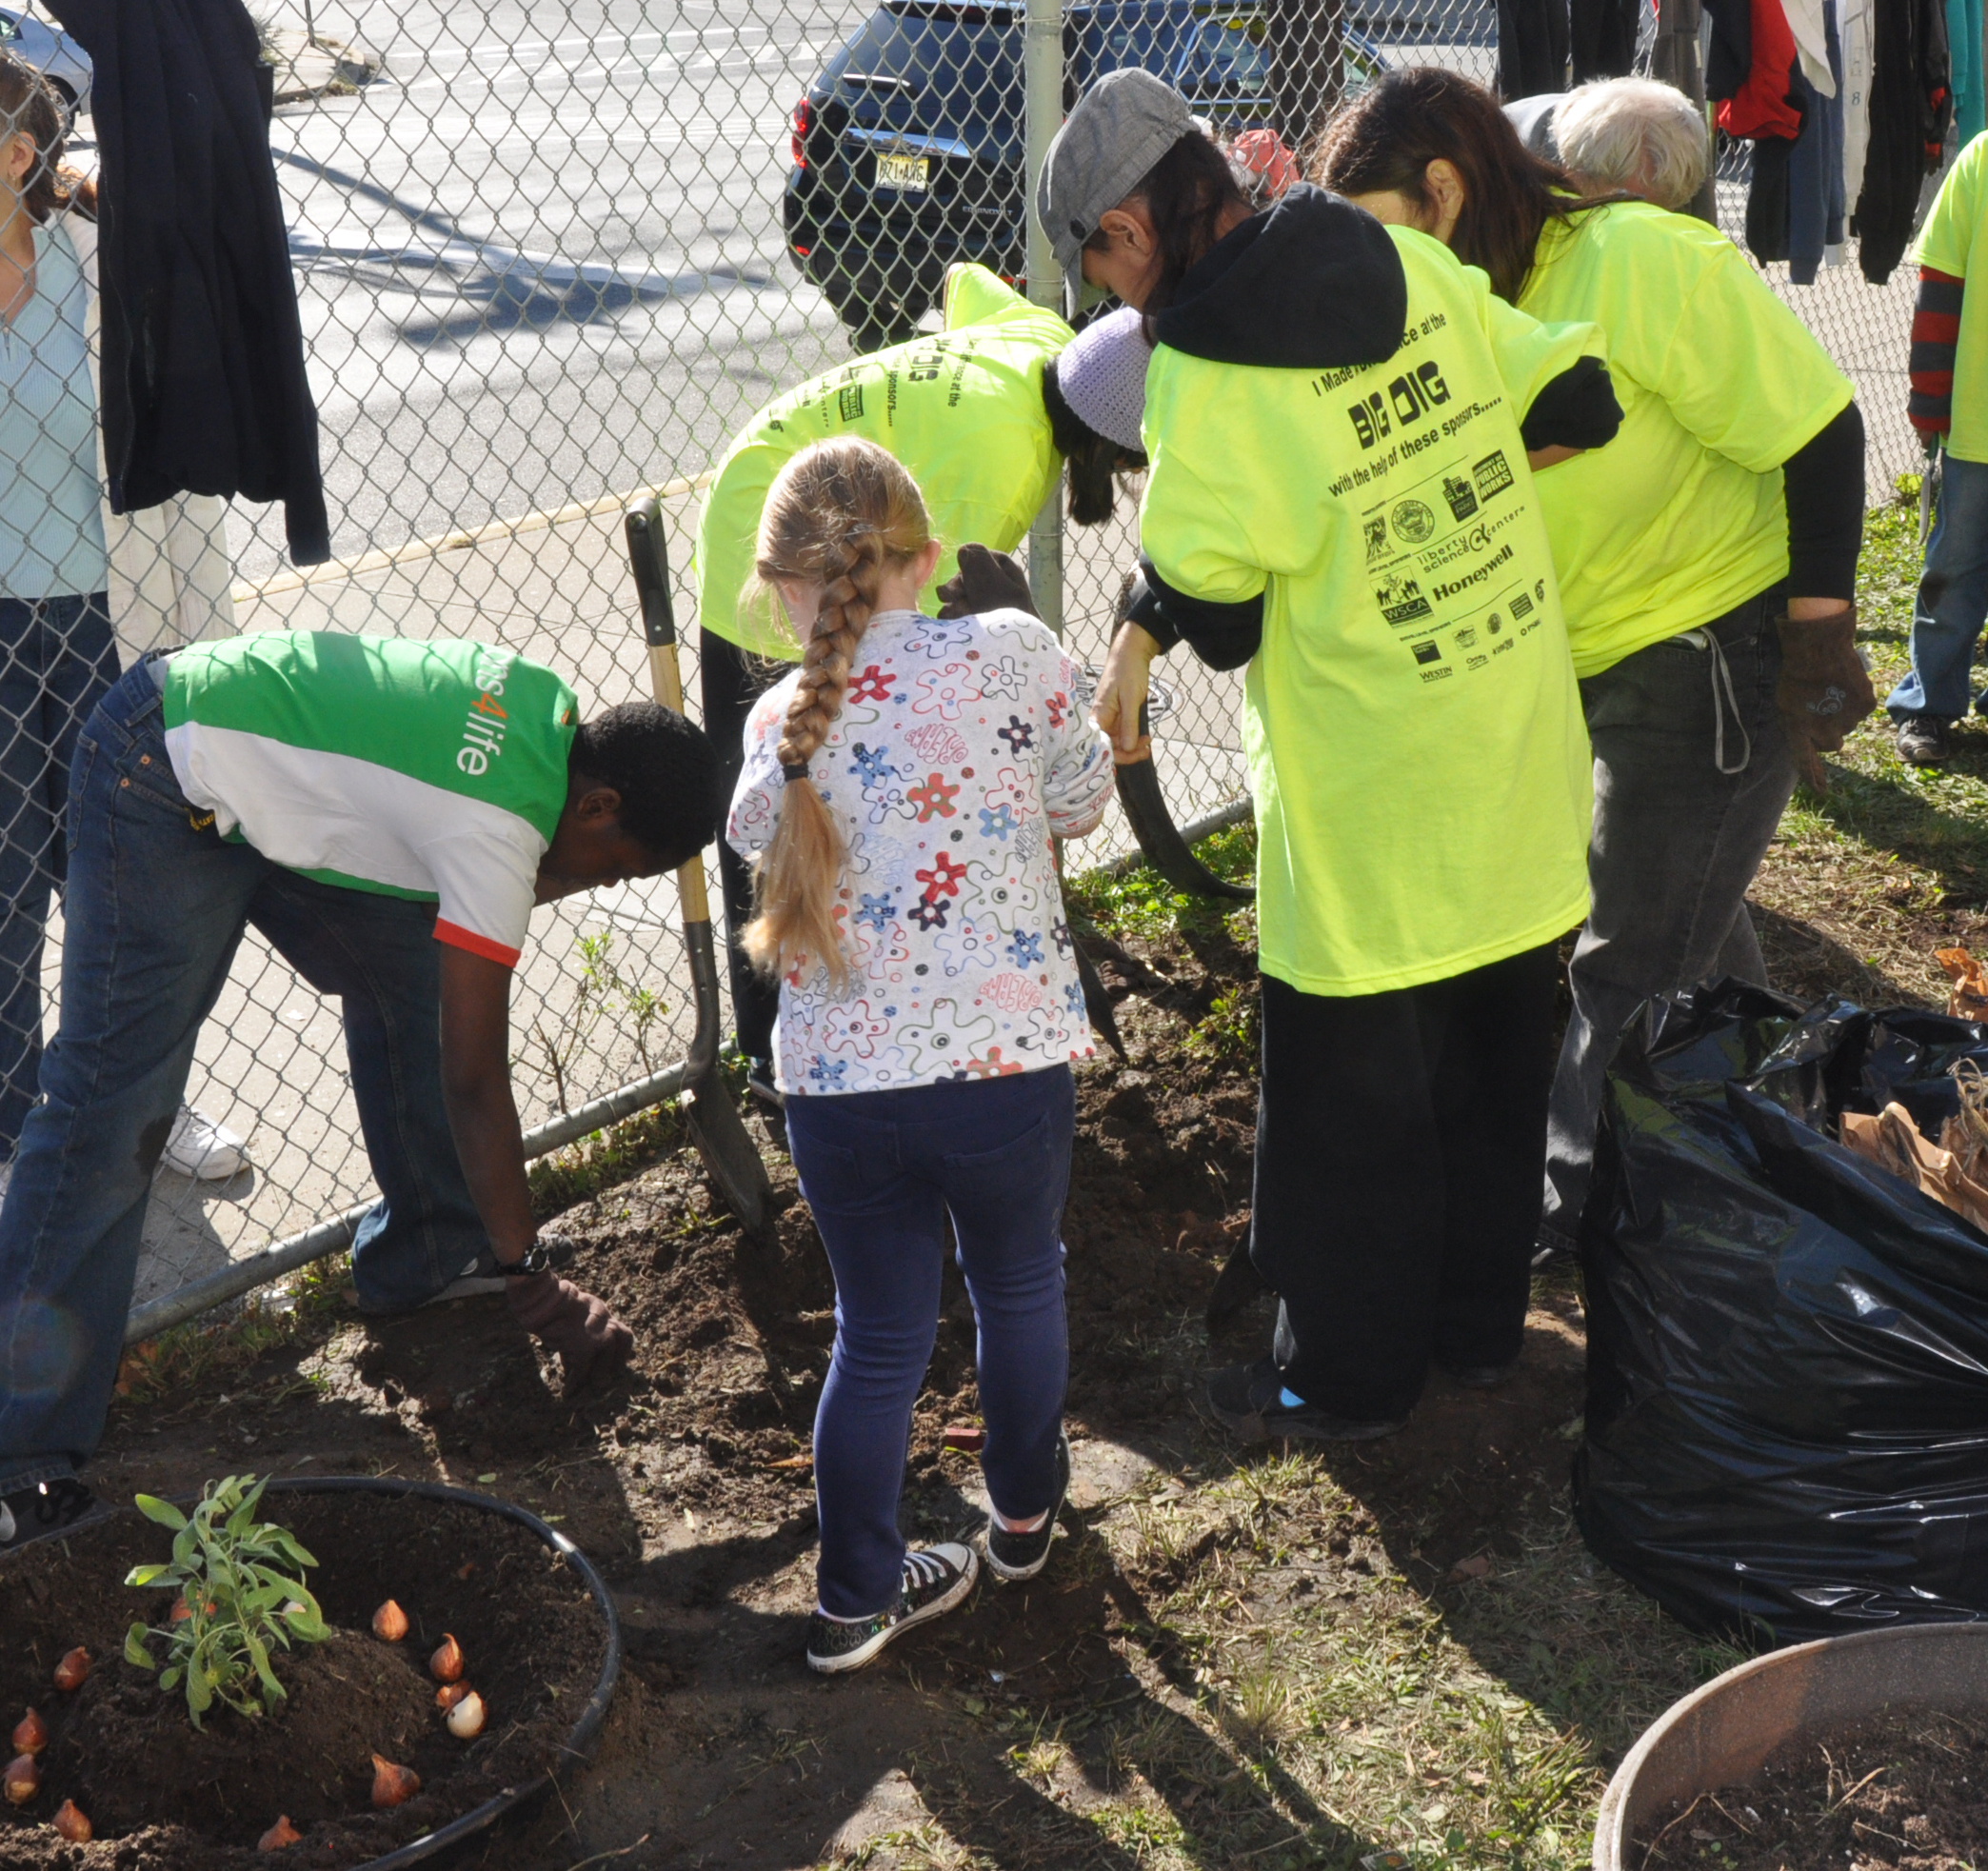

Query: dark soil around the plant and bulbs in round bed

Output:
[0, 1491, 605, 1871]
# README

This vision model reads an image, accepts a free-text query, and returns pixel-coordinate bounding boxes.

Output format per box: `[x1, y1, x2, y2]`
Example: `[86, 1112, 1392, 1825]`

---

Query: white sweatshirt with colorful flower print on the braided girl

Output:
[726, 610, 1113, 1096]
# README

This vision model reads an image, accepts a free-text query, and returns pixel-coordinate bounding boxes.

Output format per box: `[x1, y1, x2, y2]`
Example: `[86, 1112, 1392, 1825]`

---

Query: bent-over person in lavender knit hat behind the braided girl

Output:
[696, 265, 1147, 1104]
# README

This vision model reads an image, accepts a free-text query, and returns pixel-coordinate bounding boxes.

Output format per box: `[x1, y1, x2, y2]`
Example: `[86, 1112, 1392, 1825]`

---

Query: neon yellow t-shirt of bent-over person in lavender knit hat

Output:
[694, 267, 1074, 662]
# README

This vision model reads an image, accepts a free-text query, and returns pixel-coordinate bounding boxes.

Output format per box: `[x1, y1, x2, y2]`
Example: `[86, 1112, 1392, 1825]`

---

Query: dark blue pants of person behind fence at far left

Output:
[0, 590, 117, 1164]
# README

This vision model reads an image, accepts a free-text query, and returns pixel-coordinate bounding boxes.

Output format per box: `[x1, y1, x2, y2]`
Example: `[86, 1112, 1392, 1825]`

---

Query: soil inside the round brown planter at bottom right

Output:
[1628, 1714, 1988, 1871]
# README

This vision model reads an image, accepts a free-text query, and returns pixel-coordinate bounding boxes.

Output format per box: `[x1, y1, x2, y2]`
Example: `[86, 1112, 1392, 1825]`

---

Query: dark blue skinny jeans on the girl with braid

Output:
[787, 1065, 1076, 1619]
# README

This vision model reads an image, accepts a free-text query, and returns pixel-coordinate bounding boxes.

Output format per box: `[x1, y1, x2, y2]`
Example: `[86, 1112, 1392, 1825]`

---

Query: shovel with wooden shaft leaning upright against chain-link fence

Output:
[626, 495, 773, 1243]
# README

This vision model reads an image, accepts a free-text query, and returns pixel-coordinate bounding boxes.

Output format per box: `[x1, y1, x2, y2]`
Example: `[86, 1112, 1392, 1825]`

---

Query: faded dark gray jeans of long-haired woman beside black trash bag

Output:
[1539, 585, 1795, 1253]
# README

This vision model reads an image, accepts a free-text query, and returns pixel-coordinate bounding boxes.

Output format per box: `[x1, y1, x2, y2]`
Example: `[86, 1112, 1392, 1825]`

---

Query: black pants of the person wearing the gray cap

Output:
[1250, 943, 1559, 1422]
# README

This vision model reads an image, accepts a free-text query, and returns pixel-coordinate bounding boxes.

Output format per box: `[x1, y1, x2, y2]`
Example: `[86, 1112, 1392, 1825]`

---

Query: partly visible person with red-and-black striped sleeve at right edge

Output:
[1884, 133, 1988, 767]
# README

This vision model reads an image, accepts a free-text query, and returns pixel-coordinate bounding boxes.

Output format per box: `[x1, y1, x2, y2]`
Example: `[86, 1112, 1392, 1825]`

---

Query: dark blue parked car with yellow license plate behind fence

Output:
[785, 0, 1382, 352]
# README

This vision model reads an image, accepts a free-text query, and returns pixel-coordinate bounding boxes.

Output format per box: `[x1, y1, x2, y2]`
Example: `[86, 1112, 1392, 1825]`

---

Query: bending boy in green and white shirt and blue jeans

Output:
[0, 630, 720, 1551]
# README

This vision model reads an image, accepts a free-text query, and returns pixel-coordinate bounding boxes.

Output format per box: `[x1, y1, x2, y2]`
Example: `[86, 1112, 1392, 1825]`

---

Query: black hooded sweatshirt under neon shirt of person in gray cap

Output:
[1125, 183, 1622, 670]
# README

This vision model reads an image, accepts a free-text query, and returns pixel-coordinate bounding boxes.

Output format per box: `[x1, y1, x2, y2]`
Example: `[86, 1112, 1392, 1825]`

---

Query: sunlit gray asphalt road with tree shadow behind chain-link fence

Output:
[241, 0, 868, 577]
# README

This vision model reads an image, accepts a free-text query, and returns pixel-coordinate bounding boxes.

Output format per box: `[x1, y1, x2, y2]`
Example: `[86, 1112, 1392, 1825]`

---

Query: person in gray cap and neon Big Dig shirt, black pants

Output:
[1036, 71, 1620, 1442]
